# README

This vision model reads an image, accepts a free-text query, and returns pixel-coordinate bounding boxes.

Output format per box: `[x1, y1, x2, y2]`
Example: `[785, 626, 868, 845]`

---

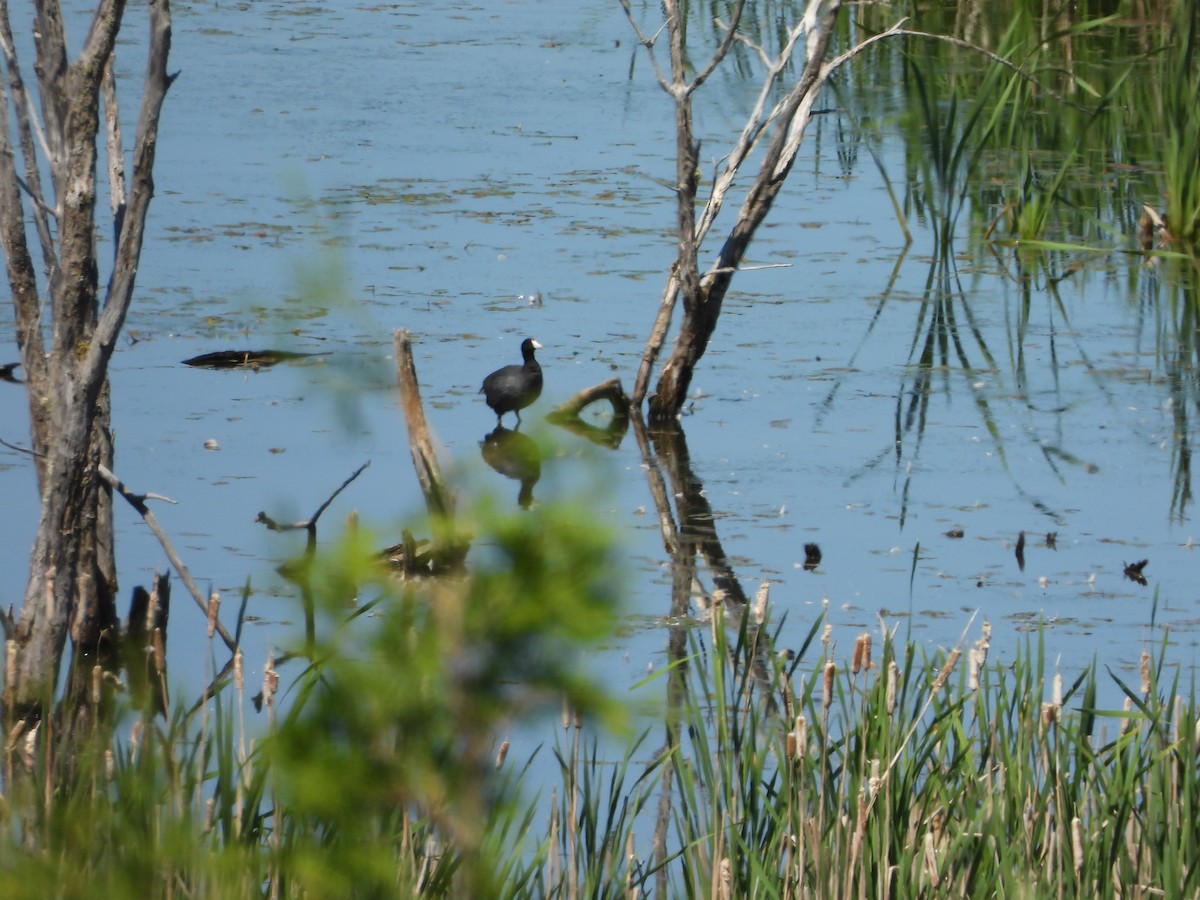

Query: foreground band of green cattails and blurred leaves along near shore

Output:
[0, 547, 1200, 898]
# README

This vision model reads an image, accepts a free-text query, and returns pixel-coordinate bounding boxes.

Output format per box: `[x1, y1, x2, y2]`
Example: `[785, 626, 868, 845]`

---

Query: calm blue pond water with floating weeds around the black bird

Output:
[0, 0, 1200, 720]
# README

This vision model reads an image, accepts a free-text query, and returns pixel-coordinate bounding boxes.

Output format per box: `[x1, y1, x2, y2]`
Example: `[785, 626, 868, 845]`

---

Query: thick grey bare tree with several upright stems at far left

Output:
[0, 0, 172, 726]
